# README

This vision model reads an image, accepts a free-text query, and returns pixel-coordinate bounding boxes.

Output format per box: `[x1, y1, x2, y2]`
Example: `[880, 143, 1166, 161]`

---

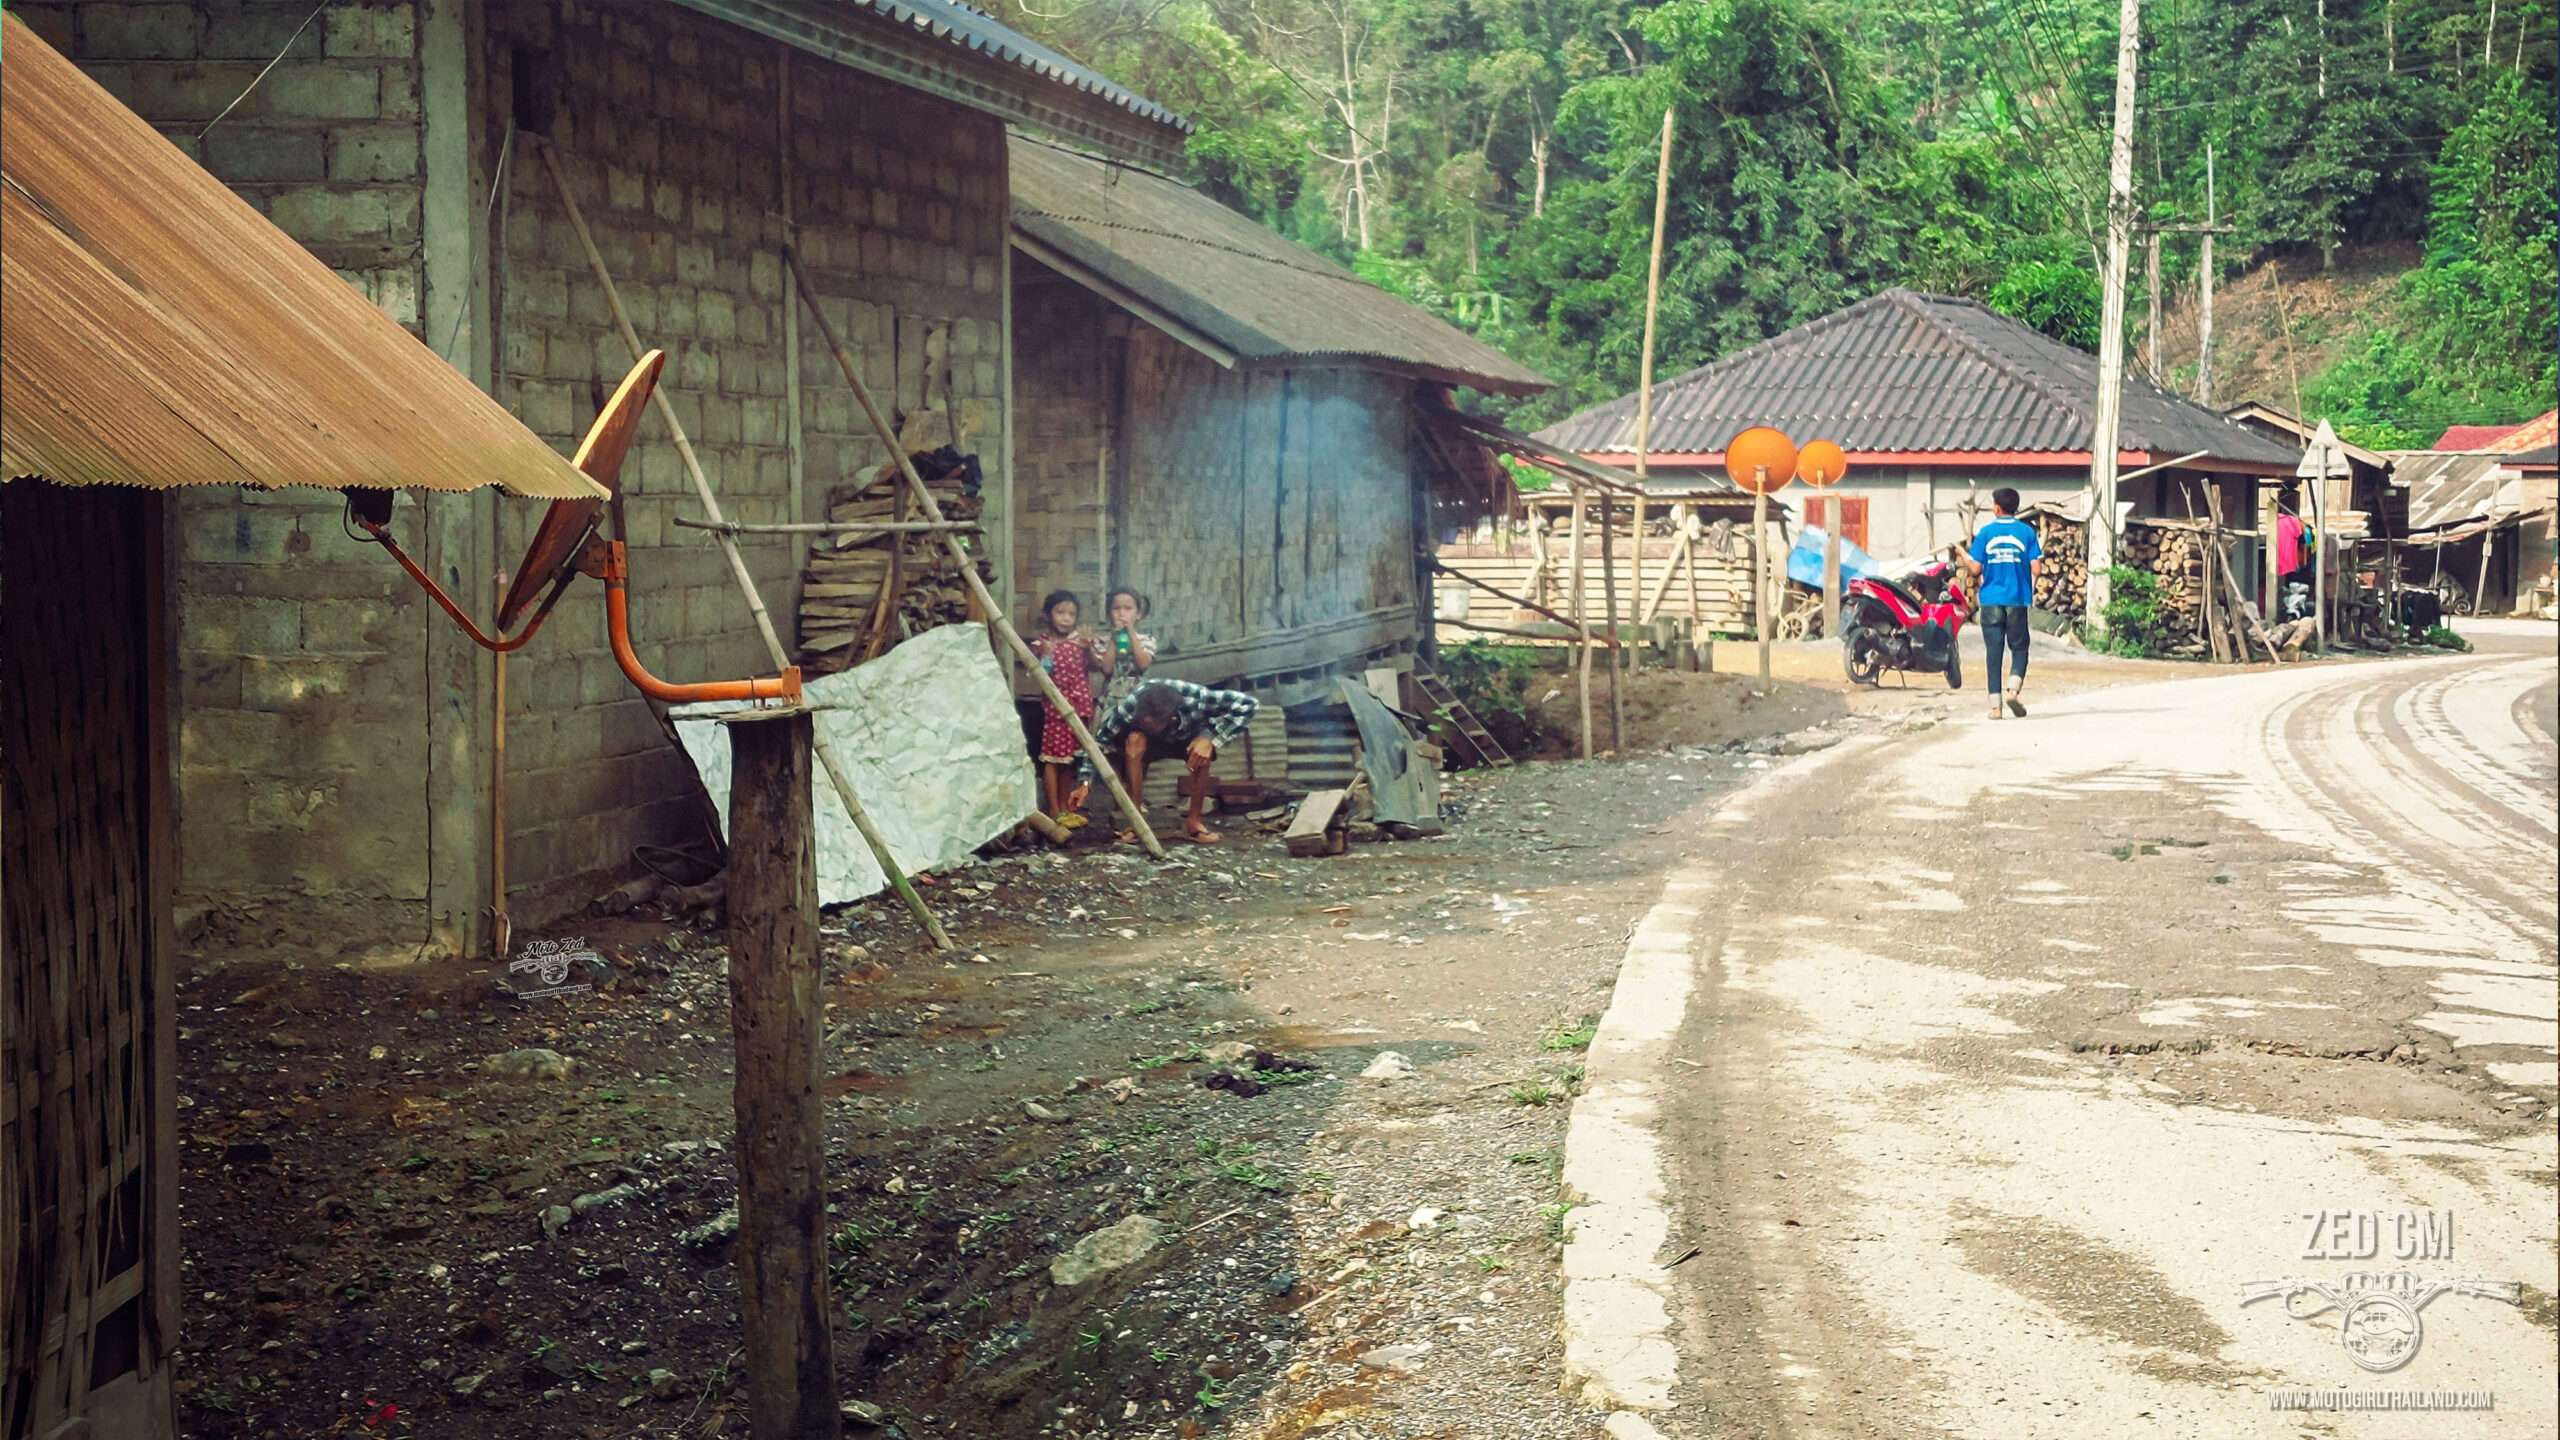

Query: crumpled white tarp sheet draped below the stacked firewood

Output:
[673, 625, 1039, 904]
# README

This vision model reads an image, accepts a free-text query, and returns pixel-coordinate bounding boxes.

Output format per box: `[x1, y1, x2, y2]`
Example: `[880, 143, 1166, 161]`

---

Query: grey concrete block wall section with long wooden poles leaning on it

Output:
[479, 0, 1006, 922]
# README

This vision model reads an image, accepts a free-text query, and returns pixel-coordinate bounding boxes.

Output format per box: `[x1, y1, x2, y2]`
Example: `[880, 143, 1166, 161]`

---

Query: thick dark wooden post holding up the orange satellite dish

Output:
[727, 710, 845, 1440]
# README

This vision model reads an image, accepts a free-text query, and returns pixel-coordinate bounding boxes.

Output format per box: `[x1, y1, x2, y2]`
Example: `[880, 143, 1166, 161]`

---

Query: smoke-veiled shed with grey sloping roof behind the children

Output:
[1011, 133, 1549, 763]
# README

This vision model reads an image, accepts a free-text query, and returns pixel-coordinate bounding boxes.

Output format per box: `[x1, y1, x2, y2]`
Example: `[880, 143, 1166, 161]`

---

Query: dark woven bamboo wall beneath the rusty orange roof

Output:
[0, 482, 177, 1440]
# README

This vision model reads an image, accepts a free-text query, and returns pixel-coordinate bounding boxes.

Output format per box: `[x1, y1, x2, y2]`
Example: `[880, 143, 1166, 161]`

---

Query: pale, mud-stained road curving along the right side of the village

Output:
[1597, 623, 2560, 1440]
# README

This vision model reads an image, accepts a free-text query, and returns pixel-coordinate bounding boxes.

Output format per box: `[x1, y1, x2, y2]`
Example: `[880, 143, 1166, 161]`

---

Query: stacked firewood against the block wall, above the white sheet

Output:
[799, 469, 993, 674]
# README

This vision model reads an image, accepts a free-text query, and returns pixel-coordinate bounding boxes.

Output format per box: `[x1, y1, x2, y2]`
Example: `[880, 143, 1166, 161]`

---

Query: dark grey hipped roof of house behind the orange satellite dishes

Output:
[1539, 290, 2301, 474]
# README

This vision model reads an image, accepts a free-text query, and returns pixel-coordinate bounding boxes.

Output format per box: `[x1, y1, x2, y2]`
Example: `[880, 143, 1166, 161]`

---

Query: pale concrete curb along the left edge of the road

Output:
[1562, 735, 1884, 1404]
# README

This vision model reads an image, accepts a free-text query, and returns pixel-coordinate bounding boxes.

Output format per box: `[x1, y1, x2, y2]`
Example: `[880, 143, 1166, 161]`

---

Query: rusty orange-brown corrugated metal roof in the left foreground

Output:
[0, 18, 604, 500]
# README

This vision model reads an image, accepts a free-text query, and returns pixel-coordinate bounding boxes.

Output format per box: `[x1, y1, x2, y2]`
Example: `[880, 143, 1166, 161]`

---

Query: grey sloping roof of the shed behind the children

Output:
[1011, 136, 1551, 395]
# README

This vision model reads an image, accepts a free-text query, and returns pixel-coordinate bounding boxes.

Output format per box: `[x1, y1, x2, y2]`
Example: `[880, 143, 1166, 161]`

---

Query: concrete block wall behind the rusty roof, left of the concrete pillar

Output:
[28, 0, 440, 938]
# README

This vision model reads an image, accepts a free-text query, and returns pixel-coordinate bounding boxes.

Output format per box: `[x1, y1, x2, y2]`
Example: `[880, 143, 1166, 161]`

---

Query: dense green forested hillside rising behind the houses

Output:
[1004, 0, 2560, 438]
